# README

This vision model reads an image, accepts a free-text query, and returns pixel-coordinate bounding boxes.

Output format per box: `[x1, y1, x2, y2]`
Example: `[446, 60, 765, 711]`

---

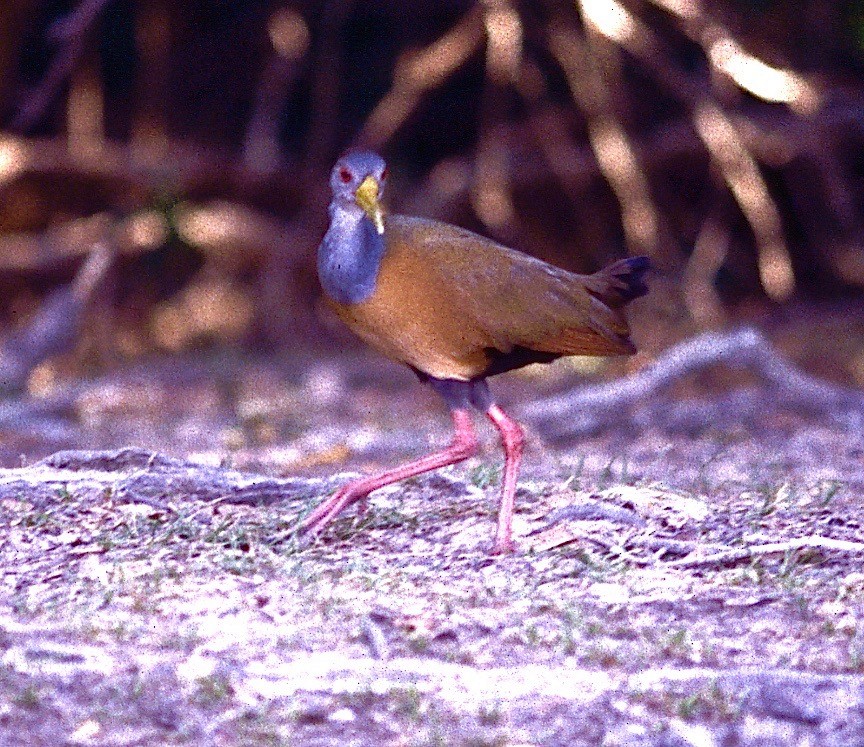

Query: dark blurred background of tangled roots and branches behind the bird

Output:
[0, 0, 864, 462]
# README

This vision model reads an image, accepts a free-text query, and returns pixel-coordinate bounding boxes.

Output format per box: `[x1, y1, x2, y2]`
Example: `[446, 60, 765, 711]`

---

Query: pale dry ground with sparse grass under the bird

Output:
[0, 348, 864, 747]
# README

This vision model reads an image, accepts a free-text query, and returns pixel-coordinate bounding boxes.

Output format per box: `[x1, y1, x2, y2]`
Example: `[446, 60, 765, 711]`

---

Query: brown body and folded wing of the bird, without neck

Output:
[335, 216, 634, 380]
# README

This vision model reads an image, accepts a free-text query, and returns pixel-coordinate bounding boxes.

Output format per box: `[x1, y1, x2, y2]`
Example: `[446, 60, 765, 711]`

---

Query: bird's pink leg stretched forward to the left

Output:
[300, 410, 477, 536]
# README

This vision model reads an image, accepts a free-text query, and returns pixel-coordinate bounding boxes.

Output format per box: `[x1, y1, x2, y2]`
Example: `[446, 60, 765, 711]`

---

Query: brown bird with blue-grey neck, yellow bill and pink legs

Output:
[298, 149, 650, 555]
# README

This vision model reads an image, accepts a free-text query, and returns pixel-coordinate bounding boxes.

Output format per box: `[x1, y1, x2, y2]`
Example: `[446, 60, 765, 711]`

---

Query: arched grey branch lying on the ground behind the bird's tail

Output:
[523, 327, 864, 439]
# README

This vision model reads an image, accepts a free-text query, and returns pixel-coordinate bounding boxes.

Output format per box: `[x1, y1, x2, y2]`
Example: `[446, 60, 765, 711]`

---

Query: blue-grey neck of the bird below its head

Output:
[318, 201, 384, 303]
